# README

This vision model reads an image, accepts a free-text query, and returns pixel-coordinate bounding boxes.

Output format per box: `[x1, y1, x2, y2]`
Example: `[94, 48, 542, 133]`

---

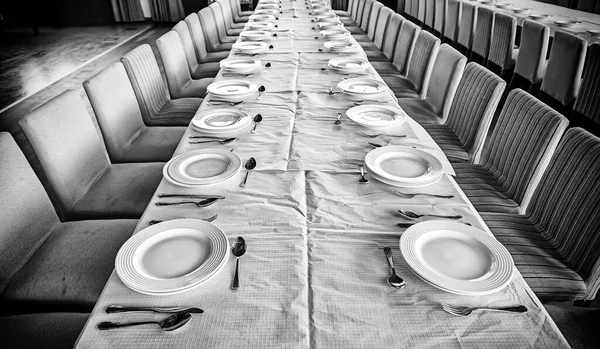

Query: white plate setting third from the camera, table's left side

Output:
[192, 109, 252, 138]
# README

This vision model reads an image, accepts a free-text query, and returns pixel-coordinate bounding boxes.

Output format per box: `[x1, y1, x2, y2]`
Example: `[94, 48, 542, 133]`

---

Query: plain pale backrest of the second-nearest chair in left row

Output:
[19, 90, 110, 212]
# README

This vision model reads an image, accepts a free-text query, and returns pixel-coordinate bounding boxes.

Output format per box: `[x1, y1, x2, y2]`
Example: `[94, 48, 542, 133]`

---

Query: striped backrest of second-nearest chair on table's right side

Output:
[481, 89, 569, 213]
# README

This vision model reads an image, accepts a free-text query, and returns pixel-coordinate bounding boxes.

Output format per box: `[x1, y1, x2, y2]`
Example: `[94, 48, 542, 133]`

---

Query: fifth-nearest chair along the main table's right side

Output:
[382, 30, 440, 99]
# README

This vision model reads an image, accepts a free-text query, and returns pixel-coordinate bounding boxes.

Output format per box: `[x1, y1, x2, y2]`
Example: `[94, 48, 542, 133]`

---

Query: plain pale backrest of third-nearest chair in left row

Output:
[83, 62, 146, 162]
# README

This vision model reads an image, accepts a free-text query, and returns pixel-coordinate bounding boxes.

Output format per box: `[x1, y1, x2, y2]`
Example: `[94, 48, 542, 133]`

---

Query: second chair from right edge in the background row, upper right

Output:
[539, 30, 587, 113]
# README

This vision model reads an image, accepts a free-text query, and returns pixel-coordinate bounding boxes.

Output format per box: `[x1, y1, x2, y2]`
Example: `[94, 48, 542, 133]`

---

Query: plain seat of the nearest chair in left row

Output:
[2, 219, 137, 313]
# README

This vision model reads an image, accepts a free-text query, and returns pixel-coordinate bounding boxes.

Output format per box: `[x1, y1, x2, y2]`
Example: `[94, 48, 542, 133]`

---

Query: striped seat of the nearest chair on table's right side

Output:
[481, 213, 586, 301]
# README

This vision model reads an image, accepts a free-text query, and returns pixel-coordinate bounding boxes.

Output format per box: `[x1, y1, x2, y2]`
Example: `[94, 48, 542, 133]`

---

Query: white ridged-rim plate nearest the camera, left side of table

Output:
[115, 219, 229, 296]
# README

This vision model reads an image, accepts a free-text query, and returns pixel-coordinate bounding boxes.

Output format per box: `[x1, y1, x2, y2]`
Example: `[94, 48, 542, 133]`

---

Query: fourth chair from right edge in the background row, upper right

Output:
[487, 12, 519, 80]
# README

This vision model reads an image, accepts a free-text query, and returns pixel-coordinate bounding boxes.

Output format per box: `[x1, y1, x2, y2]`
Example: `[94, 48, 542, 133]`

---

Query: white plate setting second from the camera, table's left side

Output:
[163, 149, 242, 187]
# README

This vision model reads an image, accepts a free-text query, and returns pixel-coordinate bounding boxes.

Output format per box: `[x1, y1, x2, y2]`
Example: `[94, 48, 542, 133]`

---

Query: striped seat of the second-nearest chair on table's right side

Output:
[452, 163, 519, 214]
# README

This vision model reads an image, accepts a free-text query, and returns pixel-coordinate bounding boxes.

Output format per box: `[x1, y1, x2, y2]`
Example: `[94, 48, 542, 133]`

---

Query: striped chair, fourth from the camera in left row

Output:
[121, 44, 202, 126]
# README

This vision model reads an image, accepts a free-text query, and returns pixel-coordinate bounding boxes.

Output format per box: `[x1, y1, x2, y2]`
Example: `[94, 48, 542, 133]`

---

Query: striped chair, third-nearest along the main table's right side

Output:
[423, 62, 506, 163]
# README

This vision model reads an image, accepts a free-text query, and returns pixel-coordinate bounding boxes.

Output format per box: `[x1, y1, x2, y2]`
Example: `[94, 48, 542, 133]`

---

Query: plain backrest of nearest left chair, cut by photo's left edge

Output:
[0, 132, 59, 294]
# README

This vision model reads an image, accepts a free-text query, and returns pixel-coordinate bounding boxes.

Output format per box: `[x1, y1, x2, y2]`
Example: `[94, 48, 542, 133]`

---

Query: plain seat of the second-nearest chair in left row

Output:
[72, 162, 164, 219]
